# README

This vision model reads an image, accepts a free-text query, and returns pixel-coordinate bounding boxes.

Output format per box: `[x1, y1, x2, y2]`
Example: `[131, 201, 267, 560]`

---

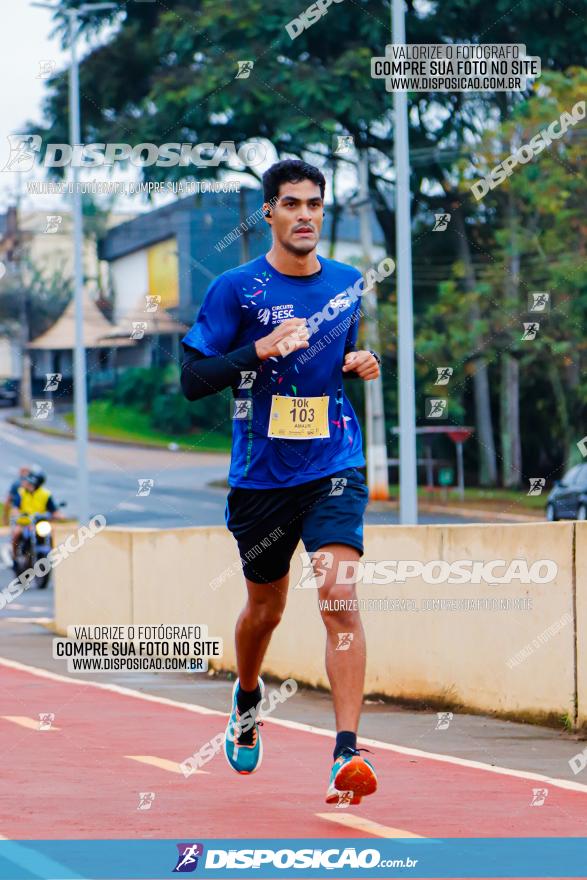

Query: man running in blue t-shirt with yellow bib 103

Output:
[181, 160, 379, 804]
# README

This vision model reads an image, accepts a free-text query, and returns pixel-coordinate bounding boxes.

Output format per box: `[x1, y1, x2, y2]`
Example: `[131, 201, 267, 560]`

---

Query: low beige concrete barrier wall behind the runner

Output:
[55, 523, 587, 722]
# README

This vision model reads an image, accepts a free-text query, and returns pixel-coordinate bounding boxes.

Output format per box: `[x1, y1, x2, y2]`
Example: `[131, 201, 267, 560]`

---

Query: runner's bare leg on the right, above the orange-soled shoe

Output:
[314, 544, 367, 733]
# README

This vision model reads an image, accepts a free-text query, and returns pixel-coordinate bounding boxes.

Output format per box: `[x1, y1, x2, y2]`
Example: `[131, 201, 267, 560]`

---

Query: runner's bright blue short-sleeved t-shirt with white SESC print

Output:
[182, 256, 365, 489]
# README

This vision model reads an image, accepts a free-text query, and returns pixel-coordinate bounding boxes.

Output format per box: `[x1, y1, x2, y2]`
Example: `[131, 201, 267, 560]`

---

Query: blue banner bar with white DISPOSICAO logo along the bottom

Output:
[0, 836, 587, 880]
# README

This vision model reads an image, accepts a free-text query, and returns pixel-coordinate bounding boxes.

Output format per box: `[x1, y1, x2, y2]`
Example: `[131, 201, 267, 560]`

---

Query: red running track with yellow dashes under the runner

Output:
[0, 663, 587, 840]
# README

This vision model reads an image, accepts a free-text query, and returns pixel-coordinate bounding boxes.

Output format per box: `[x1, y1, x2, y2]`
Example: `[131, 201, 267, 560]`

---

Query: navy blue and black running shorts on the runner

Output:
[226, 468, 369, 584]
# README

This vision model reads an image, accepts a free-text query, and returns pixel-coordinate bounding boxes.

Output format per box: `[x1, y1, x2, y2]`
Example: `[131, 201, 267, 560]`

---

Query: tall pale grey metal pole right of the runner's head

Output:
[391, 0, 418, 524]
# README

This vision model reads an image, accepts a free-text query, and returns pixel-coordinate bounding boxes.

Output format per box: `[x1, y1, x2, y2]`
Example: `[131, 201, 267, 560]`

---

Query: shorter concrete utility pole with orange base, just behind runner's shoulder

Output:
[357, 149, 389, 501]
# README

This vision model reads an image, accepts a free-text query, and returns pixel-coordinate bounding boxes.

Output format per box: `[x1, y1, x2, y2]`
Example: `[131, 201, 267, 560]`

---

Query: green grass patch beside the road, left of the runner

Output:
[64, 400, 230, 452]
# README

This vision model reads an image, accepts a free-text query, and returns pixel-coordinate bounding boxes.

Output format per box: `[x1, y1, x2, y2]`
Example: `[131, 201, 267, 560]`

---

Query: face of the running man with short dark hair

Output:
[264, 180, 324, 256]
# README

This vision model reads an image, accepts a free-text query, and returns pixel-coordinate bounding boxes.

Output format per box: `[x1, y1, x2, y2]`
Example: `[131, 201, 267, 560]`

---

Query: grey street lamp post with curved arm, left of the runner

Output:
[31, 2, 117, 524]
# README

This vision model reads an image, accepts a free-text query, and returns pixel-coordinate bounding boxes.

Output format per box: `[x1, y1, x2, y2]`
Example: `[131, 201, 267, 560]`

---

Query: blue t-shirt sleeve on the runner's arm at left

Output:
[182, 275, 241, 357]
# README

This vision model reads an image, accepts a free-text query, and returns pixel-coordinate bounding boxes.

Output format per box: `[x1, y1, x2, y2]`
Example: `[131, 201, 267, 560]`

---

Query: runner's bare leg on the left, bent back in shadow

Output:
[235, 574, 289, 691]
